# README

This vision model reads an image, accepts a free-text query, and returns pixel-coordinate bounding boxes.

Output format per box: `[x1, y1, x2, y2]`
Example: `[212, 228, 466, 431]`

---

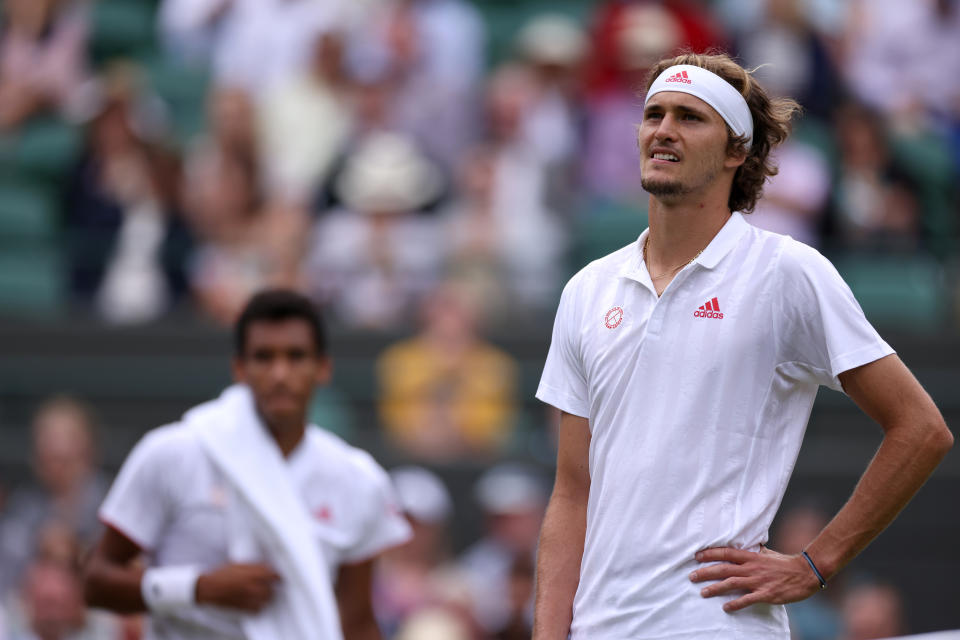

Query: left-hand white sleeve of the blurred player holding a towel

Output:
[99, 427, 180, 550]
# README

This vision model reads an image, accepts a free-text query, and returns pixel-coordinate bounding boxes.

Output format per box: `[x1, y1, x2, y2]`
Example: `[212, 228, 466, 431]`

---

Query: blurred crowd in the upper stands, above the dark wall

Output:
[0, 0, 960, 330]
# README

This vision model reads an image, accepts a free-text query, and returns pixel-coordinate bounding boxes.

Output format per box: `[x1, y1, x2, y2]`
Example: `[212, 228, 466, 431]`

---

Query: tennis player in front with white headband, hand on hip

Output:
[534, 54, 953, 640]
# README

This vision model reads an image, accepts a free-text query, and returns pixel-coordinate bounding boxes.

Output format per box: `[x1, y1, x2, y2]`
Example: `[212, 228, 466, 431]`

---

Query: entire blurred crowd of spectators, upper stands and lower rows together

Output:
[0, 0, 960, 640]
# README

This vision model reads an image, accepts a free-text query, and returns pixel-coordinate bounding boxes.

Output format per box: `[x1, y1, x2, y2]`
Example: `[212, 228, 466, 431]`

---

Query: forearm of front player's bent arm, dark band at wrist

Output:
[807, 420, 953, 579]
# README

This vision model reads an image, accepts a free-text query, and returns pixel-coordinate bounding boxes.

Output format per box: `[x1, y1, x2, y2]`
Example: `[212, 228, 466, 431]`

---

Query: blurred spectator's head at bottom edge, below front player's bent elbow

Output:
[840, 582, 907, 640]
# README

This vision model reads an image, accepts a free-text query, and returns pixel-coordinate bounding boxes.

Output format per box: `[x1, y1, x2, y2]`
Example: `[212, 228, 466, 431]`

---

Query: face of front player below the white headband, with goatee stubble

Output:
[637, 91, 743, 201]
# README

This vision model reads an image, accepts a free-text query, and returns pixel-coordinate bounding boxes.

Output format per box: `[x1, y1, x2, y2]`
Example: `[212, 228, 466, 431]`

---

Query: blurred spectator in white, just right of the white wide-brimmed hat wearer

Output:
[436, 65, 572, 317]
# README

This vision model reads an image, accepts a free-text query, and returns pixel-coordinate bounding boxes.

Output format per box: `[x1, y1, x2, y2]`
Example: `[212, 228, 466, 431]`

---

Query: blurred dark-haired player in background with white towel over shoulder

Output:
[85, 290, 409, 640]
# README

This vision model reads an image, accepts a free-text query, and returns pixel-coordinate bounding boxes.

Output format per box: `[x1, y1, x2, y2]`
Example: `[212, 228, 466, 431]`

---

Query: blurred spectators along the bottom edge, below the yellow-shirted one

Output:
[0, 396, 924, 640]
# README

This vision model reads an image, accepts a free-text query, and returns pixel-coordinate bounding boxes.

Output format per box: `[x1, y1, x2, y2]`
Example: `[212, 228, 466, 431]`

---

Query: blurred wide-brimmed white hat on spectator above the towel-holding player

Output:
[335, 133, 441, 213]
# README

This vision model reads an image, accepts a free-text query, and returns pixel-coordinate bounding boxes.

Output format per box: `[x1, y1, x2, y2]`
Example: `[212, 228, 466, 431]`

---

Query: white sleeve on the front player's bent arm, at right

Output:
[774, 240, 894, 391]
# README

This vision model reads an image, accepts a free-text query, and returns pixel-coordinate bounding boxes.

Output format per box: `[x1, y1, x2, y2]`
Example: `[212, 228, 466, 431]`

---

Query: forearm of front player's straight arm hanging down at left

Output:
[533, 491, 587, 640]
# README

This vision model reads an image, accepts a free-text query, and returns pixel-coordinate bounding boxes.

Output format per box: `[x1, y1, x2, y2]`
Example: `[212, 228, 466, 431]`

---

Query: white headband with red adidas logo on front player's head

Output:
[644, 64, 753, 150]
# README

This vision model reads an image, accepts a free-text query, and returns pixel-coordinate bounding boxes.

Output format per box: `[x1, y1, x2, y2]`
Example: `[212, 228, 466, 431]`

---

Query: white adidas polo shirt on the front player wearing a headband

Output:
[537, 213, 893, 640]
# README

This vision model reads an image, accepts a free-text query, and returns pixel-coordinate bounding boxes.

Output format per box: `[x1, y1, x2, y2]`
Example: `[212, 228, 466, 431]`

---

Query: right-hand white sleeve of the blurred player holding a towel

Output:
[342, 452, 412, 563]
